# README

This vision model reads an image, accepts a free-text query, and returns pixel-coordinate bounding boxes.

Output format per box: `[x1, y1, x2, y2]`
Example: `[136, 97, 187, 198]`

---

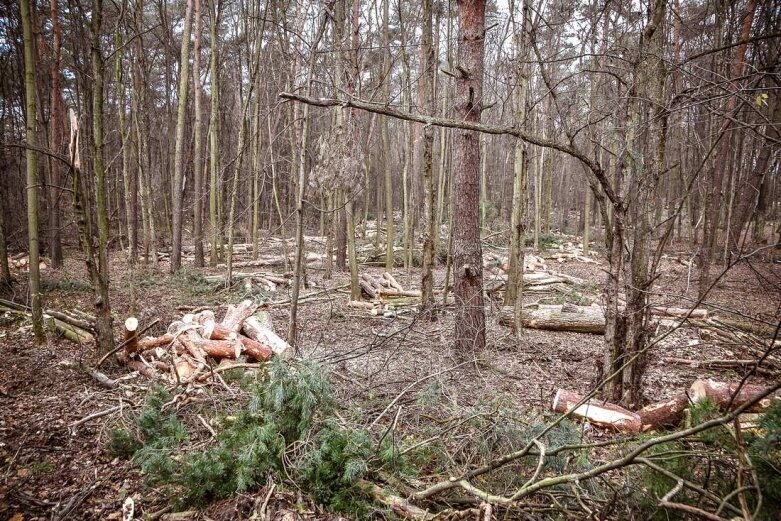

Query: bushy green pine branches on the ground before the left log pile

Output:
[107, 362, 393, 518]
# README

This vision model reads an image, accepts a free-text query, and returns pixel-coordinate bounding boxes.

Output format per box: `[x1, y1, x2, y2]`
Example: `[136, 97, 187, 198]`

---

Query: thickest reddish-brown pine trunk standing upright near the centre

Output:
[453, 0, 485, 357]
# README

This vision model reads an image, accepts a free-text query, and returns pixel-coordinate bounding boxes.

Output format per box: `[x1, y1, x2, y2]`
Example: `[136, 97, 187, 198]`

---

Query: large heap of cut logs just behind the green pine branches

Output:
[118, 300, 293, 383]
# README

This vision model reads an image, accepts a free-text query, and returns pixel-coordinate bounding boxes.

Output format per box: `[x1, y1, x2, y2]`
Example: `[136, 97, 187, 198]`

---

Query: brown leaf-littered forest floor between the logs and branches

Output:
[0, 234, 781, 521]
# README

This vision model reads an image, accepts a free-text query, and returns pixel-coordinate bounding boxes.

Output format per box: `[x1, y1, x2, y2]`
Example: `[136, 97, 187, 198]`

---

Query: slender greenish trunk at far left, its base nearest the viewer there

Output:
[19, 0, 46, 344]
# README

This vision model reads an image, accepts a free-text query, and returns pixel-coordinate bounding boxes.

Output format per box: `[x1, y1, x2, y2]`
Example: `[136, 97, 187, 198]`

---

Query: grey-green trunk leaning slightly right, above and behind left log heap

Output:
[171, 0, 193, 273]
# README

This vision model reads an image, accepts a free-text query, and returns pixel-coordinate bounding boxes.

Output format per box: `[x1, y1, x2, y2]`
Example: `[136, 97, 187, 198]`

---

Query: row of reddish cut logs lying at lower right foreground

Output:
[552, 380, 781, 433]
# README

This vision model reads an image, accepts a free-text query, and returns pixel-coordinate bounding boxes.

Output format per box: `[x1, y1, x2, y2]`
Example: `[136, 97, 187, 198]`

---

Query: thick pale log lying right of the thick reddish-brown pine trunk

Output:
[499, 305, 605, 335]
